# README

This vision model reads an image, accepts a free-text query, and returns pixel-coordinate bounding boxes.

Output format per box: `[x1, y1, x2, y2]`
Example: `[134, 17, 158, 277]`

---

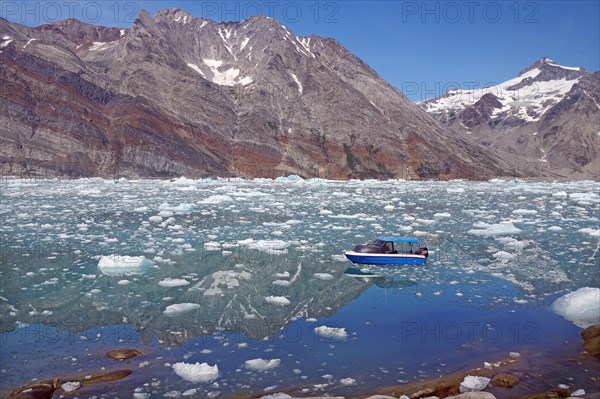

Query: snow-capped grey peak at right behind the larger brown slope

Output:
[419, 57, 600, 179]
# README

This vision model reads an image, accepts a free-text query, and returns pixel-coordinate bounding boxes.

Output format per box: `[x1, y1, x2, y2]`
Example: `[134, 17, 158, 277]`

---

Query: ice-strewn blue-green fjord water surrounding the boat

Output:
[0, 177, 600, 397]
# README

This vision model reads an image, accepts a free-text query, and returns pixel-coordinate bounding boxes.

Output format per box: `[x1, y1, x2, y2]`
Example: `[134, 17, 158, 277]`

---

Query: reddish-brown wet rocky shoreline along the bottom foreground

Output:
[8, 325, 600, 399]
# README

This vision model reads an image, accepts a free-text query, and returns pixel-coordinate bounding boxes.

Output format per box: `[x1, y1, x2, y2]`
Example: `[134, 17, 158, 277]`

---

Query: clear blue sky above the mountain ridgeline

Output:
[0, 0, 600, 101]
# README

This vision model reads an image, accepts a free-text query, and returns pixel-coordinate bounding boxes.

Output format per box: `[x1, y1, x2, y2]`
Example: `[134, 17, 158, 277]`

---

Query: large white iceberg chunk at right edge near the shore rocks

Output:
[552, 287, 600, 328]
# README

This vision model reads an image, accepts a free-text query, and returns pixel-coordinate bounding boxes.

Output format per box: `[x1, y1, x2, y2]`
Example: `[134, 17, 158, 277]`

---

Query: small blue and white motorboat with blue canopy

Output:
[344, 237, 429, 265]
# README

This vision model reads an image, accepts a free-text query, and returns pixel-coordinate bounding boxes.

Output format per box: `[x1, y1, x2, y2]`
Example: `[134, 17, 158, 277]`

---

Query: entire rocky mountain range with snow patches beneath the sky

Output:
[0, 9, 600, 179]
